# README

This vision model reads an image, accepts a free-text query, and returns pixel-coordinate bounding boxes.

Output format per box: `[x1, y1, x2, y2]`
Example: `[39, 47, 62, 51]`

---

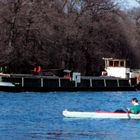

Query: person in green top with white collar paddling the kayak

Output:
[128, 98, 140, 114]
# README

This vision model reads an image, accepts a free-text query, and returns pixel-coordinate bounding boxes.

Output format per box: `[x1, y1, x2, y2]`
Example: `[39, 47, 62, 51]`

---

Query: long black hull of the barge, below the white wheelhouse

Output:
[0, 74, 136, 92]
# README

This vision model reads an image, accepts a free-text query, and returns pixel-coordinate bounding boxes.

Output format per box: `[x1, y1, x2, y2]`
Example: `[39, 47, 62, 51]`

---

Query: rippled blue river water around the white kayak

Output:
[0, 92, 140, 140]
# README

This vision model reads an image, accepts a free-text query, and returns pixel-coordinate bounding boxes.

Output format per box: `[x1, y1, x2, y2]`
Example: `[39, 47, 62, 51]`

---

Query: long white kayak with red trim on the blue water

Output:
[62, 110, 140, 119]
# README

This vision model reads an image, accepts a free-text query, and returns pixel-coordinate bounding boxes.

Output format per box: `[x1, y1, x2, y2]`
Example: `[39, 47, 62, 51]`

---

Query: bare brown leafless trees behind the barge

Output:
[0, 0, 140, 75]
